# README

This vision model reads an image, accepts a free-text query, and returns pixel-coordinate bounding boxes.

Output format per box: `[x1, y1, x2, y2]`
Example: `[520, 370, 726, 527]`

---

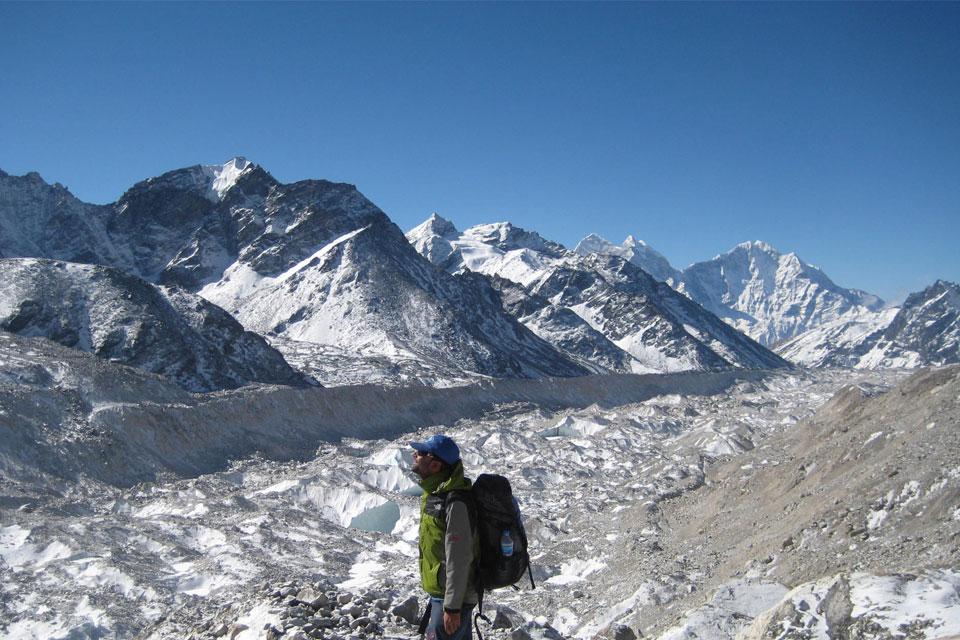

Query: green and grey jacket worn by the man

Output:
[420, 462, 478, 611]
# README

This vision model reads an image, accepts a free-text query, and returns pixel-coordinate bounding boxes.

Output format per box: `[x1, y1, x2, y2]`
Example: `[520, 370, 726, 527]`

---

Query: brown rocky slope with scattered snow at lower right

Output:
[618, 367, 960, 638]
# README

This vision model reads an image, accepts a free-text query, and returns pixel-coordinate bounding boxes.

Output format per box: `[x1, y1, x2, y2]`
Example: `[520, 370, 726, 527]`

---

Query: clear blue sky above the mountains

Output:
[0, 3, 960, 299]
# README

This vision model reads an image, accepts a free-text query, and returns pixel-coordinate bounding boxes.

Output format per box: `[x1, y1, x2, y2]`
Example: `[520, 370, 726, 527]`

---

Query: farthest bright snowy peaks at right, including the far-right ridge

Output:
[577, 236, 960, 368]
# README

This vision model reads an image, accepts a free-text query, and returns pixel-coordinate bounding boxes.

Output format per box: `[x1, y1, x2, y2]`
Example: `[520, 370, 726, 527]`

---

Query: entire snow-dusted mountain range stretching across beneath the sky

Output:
[0, 158, 957, 391]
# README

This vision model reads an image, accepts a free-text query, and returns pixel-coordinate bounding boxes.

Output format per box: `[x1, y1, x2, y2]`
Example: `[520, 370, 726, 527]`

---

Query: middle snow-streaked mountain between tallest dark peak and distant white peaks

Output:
[407, 215, 787, 372]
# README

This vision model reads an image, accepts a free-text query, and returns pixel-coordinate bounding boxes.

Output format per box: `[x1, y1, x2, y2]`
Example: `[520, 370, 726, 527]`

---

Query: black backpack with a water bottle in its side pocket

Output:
[444, 473, 536, 639]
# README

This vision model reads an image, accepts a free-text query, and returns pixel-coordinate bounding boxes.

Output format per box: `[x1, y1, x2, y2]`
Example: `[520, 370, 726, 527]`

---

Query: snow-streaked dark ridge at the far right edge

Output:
[777, 280, 960, 369]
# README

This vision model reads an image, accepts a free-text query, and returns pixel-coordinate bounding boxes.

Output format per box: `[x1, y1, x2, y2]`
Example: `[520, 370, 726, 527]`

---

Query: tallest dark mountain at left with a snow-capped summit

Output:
[0, 158, 588, 376]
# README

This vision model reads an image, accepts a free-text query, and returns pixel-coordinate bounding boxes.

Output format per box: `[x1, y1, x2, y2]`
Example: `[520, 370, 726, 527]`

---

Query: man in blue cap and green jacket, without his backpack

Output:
[410, 435, 477, 640]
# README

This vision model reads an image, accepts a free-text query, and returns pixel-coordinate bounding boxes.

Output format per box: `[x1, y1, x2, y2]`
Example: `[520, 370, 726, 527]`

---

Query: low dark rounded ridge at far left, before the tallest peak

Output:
[0, 258, 310, 392]
